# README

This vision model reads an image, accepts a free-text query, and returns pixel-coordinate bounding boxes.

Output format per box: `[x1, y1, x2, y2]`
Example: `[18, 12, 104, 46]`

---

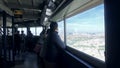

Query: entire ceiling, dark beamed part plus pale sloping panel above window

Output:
[0, 0, 103, 26]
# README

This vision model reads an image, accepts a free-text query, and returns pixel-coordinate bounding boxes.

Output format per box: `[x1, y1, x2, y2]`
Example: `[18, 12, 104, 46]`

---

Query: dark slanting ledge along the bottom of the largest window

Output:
[66, 46, 106, 68]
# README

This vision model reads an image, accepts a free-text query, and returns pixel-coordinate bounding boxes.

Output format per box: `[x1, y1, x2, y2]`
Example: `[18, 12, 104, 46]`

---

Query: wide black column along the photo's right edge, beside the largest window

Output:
[104, 0, 120, 68]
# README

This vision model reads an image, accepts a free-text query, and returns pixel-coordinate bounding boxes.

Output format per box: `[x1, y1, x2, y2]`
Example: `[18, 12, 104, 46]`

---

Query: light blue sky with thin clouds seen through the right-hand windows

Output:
[59, 4, 104, 32]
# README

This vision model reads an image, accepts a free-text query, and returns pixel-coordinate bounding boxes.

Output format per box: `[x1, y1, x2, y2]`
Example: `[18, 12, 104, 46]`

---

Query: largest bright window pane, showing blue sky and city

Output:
[66, 4, 105, 61]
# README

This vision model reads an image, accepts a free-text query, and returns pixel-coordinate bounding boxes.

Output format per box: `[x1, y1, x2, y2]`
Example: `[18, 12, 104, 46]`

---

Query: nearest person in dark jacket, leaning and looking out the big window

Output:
[45, 22, 66, 68]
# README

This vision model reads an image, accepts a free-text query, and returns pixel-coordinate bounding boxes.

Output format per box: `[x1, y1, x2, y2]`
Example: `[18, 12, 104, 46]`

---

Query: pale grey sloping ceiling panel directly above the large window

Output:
[51, 0, 103, 21]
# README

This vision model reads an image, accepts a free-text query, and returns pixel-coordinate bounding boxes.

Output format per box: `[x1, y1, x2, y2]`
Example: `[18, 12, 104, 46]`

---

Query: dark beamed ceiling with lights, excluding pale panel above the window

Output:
[0, 0, 71, 26]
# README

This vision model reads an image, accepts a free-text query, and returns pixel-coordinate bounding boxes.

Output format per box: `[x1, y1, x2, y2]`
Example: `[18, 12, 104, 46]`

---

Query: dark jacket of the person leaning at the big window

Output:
[46, 31, 66, 62]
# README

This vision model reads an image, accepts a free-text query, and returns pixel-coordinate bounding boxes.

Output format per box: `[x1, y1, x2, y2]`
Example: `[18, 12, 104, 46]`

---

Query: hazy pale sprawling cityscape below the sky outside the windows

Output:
[60, 33, 105, 61]
